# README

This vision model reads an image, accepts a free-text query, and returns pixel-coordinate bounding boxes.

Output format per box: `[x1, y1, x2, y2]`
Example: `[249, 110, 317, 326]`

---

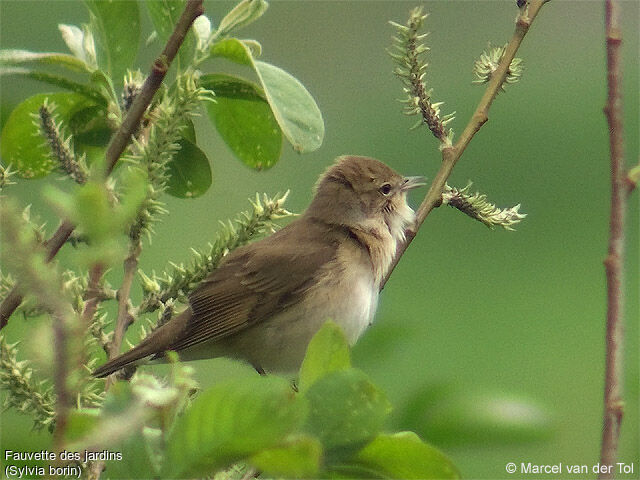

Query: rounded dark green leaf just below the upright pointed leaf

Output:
[304, 368, 391, 450]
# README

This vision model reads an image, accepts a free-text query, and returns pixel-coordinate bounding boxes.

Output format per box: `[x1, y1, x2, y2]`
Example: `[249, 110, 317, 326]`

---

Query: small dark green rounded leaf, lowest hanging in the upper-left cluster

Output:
[167, 138, 211, 198]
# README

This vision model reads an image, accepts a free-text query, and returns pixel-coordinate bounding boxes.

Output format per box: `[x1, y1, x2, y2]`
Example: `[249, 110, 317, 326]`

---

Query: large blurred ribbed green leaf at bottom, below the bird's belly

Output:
[162, 377, 306, 478]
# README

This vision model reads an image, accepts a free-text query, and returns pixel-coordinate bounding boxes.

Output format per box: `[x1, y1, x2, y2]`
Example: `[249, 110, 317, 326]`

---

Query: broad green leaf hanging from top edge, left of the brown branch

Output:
[85, 0, 140, 85]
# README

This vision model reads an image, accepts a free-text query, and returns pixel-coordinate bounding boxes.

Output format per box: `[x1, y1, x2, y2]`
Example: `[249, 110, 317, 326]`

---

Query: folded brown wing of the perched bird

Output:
[170, 218, 345, 350]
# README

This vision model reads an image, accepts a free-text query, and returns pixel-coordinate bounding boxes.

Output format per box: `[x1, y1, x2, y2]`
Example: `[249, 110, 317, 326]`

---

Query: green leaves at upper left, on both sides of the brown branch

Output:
[0, 0, 324, 191]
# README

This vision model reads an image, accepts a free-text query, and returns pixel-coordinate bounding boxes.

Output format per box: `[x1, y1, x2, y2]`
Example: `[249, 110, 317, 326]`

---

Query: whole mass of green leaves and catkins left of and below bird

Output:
[0, 0, 455, 478]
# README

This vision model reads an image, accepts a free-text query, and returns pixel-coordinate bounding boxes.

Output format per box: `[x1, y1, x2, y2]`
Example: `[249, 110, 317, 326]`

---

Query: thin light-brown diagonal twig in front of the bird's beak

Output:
[380, 0, 549, 290]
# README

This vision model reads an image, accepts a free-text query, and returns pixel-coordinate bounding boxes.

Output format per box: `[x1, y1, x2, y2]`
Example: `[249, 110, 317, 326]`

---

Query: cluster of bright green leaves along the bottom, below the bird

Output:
[68, 322, 458, 478]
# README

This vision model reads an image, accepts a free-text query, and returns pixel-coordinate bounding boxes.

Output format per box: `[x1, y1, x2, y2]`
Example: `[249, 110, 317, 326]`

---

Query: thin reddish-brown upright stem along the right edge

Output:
[599, 0, 629, 478]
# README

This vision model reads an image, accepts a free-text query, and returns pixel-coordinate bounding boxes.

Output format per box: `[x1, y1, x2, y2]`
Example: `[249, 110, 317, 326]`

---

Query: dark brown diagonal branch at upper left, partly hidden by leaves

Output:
[0, 0, 204, 329]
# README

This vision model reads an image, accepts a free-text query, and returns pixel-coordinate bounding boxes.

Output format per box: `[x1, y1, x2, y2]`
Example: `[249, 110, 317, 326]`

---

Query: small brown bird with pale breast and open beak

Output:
[93, 155, 425, 377]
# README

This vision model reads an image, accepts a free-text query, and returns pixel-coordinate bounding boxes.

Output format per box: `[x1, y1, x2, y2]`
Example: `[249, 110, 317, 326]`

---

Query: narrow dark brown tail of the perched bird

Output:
[92, 308, 191, 378]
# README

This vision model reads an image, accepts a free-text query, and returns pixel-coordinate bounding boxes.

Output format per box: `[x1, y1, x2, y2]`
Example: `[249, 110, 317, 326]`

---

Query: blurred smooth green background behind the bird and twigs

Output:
[0, 0, 640, 479]
